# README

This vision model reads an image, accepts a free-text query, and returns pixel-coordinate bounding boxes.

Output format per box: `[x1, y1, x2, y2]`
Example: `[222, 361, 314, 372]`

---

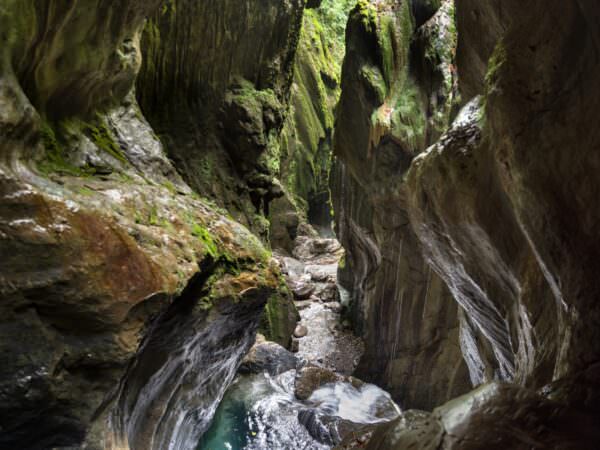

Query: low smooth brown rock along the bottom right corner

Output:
[336, 384, 600, 450]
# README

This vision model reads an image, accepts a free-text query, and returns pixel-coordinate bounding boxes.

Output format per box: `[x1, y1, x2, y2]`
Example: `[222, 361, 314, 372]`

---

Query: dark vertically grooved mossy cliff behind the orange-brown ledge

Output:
[137, 0, 304, 240]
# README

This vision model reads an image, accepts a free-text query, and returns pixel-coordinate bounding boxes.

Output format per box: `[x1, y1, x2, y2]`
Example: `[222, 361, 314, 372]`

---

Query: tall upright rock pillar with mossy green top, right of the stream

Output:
[332, 2, 470, 408]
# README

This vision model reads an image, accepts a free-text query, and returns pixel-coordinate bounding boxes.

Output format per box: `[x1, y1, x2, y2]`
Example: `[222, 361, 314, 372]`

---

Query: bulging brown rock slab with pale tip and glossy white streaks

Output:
[408, 98, 559, 386]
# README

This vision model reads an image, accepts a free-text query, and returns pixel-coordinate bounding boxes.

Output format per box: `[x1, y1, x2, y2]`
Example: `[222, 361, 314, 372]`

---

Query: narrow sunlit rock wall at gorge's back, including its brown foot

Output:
[270, 0, 354, 253]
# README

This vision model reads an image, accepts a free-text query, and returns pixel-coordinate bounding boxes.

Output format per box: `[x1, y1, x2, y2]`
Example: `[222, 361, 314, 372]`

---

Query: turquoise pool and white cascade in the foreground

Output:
[198, 370, 399, 450]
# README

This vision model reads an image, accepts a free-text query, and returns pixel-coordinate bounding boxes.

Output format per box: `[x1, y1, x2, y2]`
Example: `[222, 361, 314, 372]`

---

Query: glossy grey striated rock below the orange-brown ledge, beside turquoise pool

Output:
[108, 263, 273, 449]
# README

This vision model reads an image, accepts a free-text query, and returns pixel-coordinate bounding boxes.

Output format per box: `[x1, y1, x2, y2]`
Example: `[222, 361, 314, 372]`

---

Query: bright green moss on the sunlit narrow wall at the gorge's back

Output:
[273, 0, 356, 218]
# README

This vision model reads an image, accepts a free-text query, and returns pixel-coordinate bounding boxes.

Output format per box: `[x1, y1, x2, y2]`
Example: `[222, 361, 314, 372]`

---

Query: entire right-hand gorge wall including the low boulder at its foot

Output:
[342, 0, 600, 449]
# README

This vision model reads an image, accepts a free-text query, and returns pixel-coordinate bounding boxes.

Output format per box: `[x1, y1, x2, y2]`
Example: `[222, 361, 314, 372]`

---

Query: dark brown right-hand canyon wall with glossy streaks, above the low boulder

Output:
[408, 2, 599, 400]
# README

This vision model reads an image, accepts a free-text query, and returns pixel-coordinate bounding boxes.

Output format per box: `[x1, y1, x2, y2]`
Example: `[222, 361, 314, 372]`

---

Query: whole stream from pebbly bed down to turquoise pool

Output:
[197, 230, 400, 450]
